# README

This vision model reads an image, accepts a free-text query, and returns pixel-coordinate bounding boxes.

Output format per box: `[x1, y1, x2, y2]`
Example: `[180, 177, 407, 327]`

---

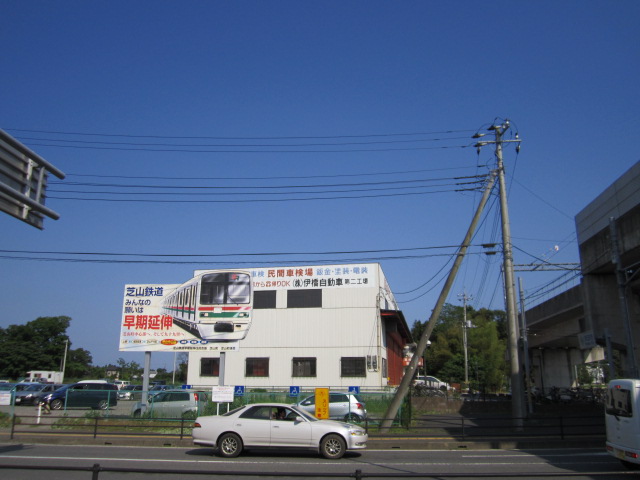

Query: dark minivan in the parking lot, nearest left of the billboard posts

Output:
[42, 380, 118, 410]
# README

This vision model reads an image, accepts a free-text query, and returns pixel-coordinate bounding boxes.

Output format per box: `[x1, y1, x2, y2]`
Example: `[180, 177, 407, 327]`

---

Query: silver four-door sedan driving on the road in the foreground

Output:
[192, 403, 368, 459]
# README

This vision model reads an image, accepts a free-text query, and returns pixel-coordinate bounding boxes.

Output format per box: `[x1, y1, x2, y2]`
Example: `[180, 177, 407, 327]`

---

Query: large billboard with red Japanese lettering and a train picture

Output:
[119, 270, 253, 352]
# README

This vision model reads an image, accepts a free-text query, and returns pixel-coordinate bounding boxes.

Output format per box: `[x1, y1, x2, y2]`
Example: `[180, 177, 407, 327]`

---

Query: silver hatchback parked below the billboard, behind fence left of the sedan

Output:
[131, 389, 209, 418]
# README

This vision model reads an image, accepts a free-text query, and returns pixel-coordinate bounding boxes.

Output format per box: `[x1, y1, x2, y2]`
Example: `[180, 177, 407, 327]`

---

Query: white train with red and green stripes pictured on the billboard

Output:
[162, 270, 253, 342]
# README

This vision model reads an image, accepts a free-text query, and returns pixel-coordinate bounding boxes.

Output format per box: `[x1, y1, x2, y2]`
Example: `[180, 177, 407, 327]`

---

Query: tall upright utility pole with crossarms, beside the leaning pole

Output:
[474, 120, 525, 426]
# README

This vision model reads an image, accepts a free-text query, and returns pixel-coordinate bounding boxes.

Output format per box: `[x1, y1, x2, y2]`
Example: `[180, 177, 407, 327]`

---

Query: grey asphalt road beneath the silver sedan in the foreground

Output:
[0, 443, 640, 480]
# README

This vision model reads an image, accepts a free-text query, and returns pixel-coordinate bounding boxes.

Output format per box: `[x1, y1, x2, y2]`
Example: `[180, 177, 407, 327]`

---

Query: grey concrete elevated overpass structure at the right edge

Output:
[525, 162, 640, 390]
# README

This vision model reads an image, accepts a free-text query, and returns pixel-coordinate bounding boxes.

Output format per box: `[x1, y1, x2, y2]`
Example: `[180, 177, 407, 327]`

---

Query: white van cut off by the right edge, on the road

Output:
[605, 379, 640, 470]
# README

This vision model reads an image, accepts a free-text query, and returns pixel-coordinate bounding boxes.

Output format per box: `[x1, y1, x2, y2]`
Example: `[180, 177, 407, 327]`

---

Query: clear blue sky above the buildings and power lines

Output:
[0, 1, 640, 369]
